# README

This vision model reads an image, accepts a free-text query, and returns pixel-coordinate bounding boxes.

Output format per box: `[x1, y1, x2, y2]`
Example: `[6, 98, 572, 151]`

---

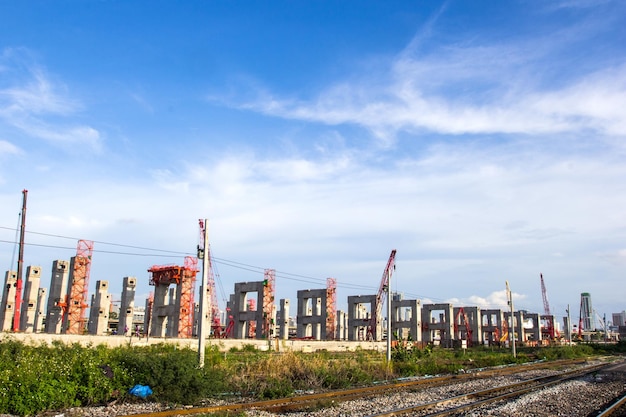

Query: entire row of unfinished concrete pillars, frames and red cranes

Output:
[0, 190, 608, 347]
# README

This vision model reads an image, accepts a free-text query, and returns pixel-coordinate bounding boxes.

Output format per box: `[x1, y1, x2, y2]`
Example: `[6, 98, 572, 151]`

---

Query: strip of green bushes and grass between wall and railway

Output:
[0, 336, 626, 416]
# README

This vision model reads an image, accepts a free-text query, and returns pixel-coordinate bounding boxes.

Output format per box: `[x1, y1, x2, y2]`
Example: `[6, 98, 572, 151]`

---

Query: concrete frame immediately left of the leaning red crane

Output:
[348, 295, 382, 341]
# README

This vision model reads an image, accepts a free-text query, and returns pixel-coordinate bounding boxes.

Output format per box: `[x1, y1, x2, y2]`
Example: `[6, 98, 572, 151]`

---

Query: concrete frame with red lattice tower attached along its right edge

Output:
[296, 288, 335, 340]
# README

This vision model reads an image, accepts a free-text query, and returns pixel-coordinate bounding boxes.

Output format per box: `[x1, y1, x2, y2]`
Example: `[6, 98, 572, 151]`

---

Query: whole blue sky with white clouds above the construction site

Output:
[0, 0, 626, 320]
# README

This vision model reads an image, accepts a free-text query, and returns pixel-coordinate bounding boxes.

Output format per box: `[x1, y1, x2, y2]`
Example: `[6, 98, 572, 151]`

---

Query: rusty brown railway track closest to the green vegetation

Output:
[120, 359, 585, 417]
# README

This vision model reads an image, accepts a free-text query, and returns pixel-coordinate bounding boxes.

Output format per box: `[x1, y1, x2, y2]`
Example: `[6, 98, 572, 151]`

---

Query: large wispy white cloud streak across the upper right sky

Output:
[228, 6, 626, 142]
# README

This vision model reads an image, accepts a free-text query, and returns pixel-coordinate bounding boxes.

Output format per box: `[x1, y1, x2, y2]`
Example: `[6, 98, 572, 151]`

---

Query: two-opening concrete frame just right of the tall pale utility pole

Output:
[229, 281, 268, 339]
